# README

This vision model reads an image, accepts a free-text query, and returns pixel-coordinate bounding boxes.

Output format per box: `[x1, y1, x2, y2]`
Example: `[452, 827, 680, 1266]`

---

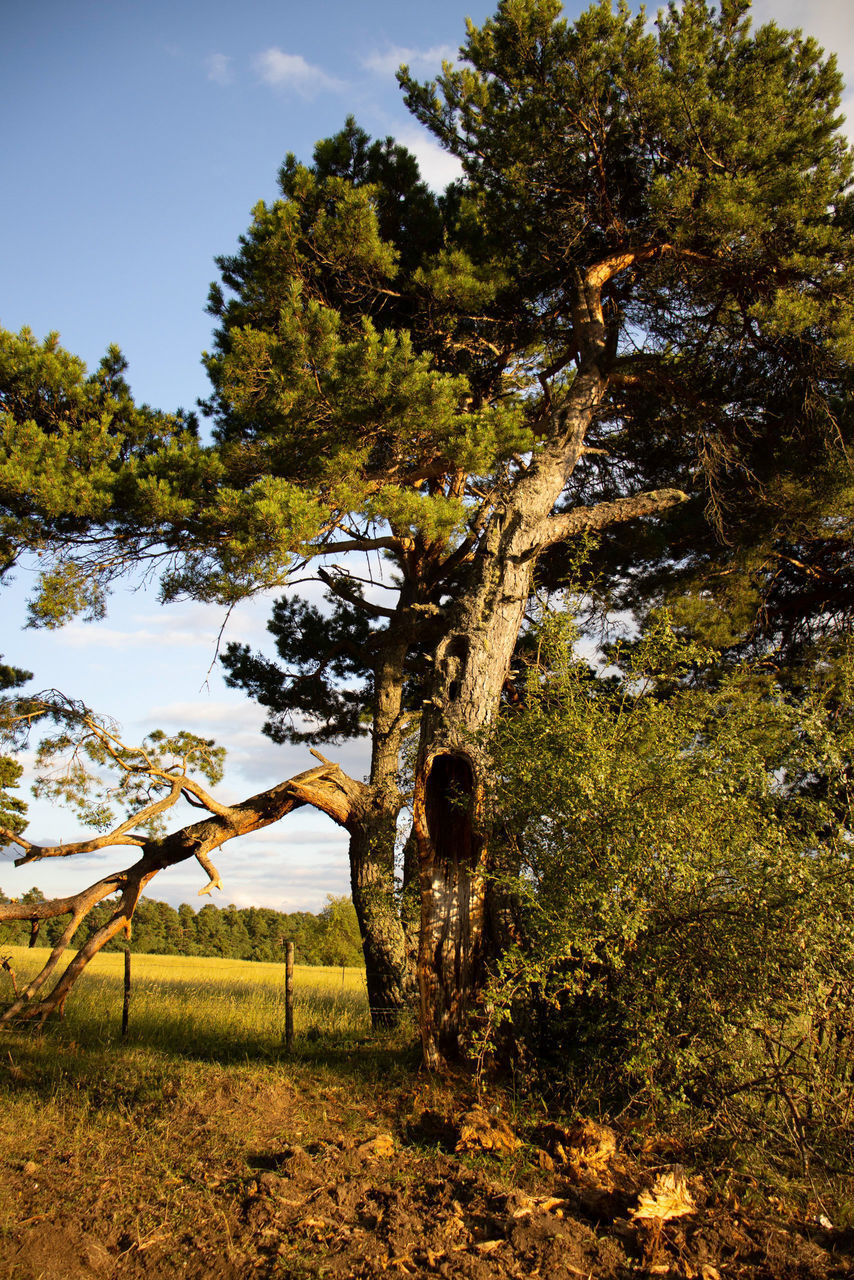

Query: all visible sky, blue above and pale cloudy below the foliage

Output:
[0, 0, 854, 910]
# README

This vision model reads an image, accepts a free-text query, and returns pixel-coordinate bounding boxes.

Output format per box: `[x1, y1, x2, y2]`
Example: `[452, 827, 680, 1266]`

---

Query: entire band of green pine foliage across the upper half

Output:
[0, 0, 854, 637]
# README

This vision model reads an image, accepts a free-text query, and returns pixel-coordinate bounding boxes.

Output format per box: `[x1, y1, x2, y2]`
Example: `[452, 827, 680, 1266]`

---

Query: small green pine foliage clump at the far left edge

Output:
[0, 329, 195, 627]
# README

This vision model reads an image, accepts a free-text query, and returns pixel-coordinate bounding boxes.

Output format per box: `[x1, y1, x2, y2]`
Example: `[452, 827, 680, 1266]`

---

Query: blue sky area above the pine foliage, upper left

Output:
[0, 0, 490, 407]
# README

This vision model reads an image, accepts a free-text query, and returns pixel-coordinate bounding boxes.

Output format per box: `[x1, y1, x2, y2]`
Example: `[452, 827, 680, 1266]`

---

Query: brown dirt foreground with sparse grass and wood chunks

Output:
[0, 1036, 854, 1280]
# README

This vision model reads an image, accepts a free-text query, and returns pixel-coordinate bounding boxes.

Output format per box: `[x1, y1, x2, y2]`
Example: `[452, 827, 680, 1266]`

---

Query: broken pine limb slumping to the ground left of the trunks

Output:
[0, 691, 371, 1023]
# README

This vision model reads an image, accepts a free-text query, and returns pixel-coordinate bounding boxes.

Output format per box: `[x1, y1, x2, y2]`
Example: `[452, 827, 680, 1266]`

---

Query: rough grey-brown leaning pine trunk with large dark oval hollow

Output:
[414, 267, 685, 1069]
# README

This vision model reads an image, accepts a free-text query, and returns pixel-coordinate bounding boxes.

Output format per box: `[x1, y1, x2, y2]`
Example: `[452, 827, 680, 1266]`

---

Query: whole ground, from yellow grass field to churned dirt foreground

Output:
[0, 947, 854, 1280]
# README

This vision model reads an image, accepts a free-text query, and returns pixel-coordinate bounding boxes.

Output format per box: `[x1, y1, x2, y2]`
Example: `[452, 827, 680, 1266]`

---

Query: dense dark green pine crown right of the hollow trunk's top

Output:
[402, 0, 854, 648]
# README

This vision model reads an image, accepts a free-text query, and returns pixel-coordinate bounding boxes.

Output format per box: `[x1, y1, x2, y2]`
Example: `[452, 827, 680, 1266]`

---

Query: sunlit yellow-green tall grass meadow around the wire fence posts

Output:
[0, 947, 370, 1061]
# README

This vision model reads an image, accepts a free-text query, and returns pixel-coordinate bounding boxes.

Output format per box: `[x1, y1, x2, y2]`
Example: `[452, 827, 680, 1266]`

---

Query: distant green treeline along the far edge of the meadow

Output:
[0, 888, 364, 965]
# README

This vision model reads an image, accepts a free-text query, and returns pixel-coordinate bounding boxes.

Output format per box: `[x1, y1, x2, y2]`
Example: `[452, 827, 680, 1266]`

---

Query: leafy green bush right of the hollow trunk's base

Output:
[483, 614, 854, 1153]
